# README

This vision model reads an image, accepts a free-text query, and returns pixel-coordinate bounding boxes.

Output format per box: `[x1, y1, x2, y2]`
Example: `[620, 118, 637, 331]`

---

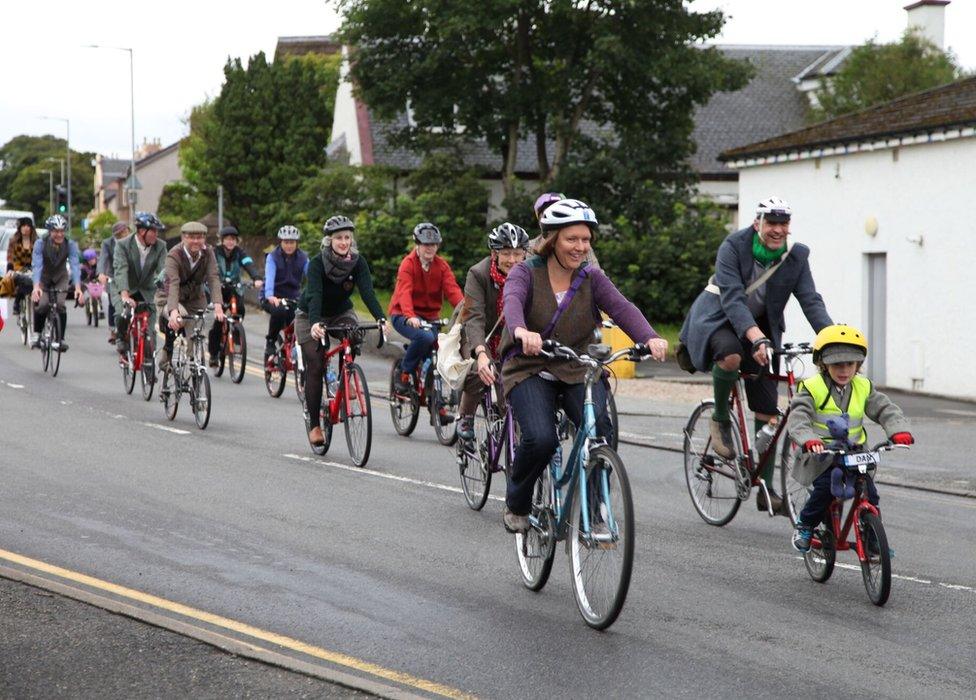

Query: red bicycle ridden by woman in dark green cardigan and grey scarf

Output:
[298, 323, 386, 467]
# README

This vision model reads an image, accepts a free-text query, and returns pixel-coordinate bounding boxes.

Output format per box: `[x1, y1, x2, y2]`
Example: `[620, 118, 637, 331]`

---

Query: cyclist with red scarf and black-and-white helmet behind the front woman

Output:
[458, 222, 529, 440]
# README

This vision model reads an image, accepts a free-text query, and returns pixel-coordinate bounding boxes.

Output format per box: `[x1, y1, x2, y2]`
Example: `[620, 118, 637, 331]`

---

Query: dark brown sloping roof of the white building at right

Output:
[721, 76, 976, 160]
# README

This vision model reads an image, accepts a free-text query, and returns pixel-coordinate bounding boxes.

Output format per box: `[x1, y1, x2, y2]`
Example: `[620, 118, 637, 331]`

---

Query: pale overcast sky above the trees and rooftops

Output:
[0, 0, 976, 157]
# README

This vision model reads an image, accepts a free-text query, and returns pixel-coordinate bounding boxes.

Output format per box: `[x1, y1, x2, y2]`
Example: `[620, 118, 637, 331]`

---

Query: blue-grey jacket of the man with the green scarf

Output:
[680, 225, 833, 372]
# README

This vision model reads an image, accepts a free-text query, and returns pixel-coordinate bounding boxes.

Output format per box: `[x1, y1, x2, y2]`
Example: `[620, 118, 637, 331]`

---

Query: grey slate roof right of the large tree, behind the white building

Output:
[691, 46, 846, 177]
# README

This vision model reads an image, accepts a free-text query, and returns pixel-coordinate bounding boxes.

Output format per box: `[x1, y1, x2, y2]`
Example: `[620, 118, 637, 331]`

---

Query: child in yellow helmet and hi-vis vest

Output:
[786, 325, 915, 552]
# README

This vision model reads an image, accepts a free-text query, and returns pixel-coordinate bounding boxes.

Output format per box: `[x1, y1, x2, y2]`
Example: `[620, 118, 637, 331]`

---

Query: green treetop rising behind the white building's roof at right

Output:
[810, 30, 962, 121]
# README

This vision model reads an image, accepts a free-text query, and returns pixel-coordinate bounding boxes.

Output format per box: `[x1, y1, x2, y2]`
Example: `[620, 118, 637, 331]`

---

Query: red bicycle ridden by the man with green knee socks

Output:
[684, 343, 813, 526]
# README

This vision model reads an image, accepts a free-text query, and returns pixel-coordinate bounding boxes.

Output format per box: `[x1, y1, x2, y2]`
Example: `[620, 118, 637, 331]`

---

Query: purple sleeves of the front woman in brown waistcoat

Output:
[503, 263, 660, 343]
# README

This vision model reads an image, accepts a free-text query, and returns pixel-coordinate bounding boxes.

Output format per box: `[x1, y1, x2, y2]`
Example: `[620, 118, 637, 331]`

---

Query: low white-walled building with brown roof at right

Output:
[722, 77, 976, 399]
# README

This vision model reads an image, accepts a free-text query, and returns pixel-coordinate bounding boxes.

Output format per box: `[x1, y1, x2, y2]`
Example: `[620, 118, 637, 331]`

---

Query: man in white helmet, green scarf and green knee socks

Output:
[680, 197, 833, 512]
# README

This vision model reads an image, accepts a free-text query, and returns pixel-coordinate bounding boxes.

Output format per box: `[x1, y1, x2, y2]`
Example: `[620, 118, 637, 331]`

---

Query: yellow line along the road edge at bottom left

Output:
[0, 549, 474, 698]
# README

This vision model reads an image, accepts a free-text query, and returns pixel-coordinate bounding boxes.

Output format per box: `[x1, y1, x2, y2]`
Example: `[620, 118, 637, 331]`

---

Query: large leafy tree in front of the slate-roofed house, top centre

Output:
[339, 0, 749, 195]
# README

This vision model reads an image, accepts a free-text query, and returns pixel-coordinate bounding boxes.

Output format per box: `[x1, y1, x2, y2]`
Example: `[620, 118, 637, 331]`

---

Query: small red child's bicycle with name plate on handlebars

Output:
[788, 441, 908, 606]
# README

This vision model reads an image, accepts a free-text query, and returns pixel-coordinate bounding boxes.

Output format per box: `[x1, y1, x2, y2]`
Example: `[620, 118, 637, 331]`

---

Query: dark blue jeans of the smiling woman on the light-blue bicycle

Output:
[505, 375, 611, 515]
